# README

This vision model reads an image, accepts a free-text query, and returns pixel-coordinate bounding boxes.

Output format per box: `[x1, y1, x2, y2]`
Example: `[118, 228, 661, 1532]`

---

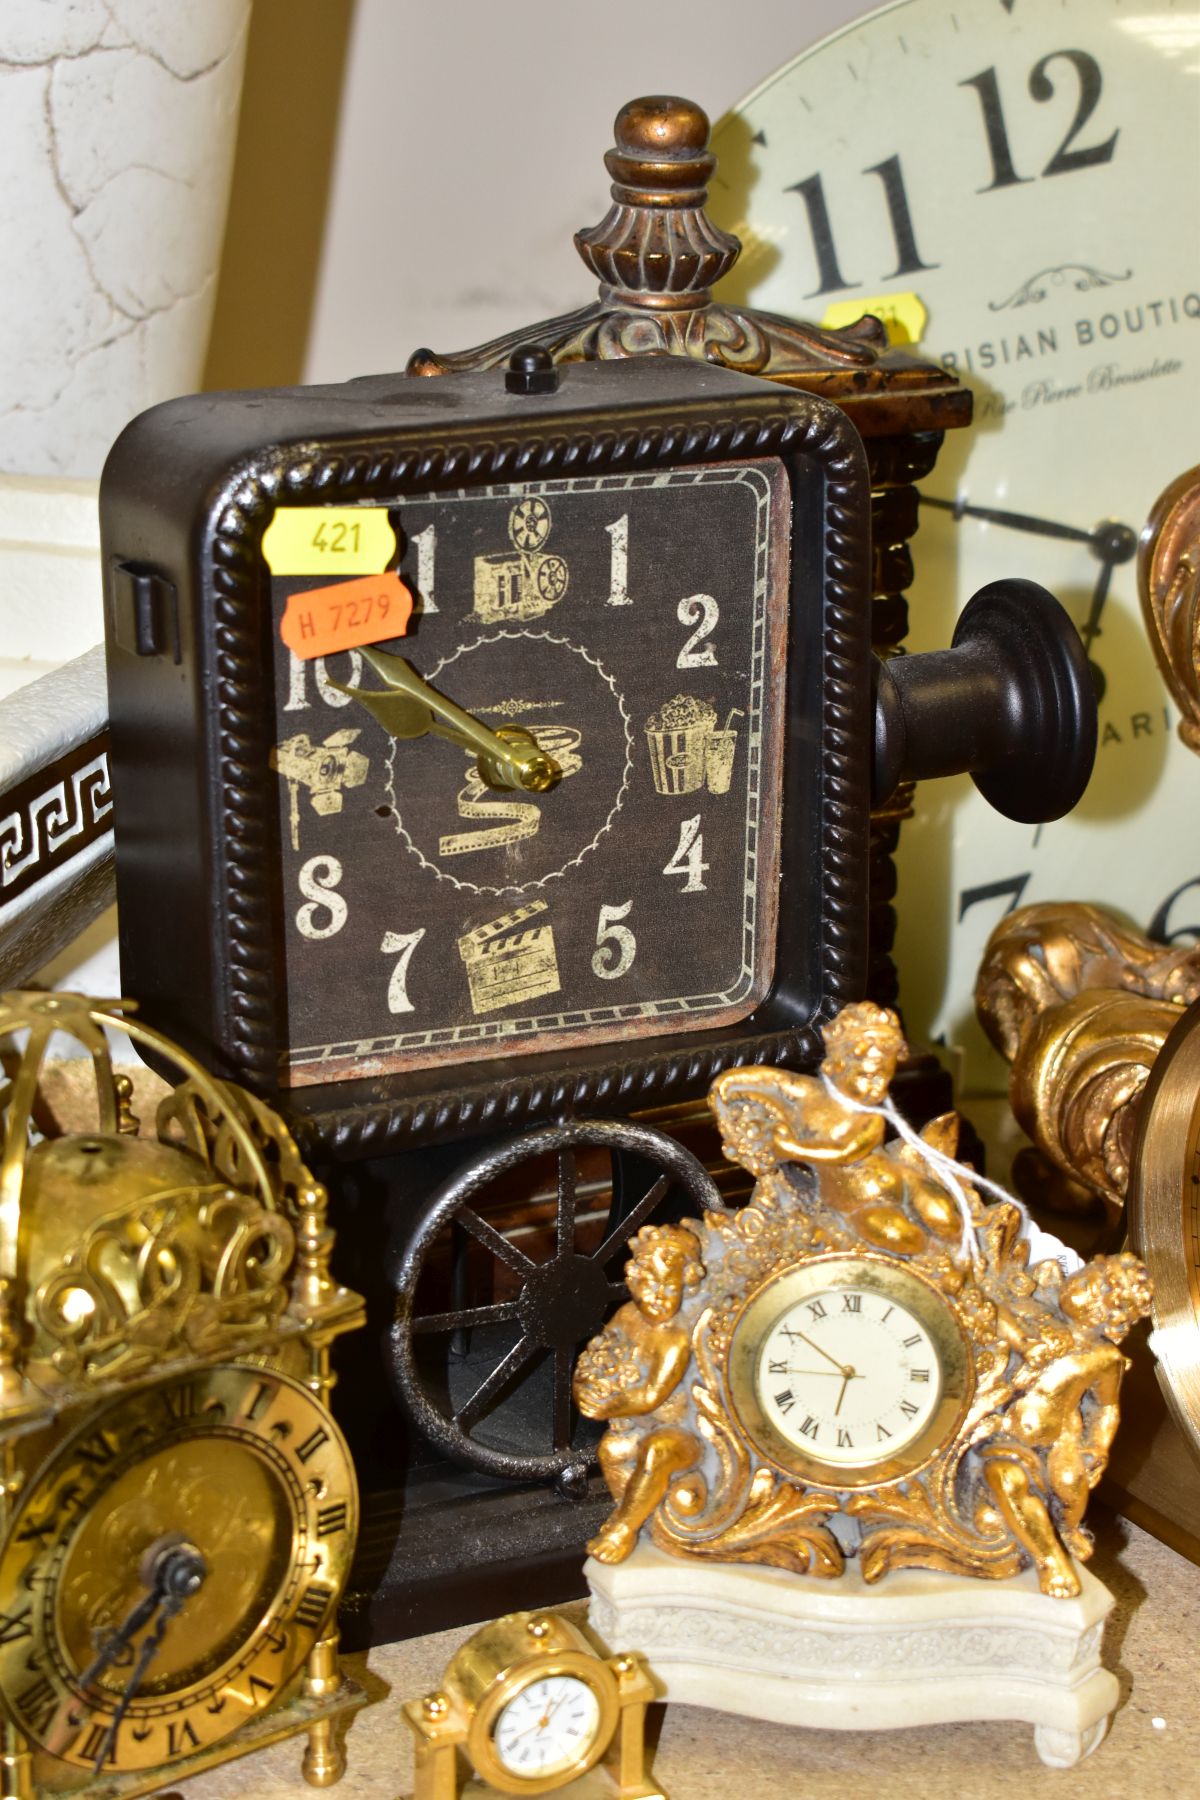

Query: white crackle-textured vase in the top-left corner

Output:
[0, 0, 250, 697]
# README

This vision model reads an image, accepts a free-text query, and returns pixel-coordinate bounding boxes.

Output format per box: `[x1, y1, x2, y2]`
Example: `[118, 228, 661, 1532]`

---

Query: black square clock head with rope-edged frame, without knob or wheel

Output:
[101, 358, 869, 1154]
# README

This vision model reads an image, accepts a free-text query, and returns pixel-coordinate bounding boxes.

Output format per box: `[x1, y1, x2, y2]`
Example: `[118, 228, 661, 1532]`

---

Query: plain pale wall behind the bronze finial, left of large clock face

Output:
[304, 0, 873, 382]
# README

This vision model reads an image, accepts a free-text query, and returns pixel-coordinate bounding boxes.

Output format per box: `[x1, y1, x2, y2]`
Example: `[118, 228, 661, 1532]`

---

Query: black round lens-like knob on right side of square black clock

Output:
[871, 581, 1097, 824]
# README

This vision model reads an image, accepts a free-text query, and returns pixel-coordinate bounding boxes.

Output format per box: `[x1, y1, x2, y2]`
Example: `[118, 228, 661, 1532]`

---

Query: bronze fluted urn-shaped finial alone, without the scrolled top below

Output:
[576, 94, 741, 311]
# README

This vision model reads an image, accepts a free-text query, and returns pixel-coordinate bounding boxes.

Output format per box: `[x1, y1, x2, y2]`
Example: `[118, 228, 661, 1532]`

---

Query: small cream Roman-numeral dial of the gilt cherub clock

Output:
[757, 1287, 941, 1463]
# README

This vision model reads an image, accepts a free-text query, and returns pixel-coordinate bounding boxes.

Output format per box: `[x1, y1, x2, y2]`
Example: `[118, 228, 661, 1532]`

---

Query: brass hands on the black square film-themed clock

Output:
[329, 650, 563, 794]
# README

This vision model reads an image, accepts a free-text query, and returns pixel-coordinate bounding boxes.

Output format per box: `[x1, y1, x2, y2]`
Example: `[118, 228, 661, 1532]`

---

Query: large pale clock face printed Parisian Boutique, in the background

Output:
[712, 0, 1200, 1085]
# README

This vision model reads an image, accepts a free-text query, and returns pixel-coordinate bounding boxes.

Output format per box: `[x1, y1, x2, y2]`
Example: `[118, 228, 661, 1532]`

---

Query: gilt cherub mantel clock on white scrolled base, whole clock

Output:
[576, 1003, 1151, 1764]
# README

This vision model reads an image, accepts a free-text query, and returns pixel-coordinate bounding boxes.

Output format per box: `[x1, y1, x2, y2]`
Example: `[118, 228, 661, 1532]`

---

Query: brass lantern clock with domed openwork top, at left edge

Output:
[0, 994, 365, 1800]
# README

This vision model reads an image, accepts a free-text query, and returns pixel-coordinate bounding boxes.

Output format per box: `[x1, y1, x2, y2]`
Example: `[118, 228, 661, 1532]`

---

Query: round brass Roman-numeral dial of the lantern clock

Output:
[0, 1364, 356, 1775]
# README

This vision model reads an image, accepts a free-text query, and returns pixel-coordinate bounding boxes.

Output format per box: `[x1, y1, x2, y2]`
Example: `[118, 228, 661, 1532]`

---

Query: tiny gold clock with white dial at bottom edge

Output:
[405, 1613, 667, 1800]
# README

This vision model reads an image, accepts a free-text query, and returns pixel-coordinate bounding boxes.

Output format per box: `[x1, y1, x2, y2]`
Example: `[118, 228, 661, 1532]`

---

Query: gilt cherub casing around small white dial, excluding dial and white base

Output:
[576, 1003, 1150, 1598]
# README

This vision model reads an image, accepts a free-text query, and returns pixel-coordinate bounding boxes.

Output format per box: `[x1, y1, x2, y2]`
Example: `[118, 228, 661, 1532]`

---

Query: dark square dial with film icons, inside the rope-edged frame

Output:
[270, 459, 792, 1085]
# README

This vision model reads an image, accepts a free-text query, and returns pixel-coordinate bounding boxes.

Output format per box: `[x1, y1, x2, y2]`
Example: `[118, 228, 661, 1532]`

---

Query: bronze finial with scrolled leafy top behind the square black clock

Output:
[408, 94, 972, 437]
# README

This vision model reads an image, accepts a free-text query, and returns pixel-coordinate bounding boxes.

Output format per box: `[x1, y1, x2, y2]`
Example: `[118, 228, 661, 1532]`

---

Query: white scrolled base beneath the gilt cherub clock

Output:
[585, 1543, 1119, 1768]
